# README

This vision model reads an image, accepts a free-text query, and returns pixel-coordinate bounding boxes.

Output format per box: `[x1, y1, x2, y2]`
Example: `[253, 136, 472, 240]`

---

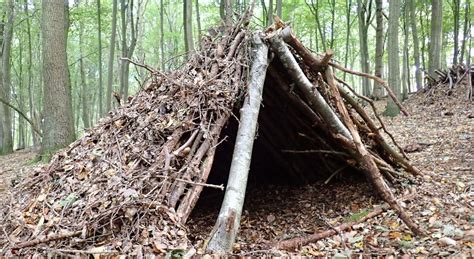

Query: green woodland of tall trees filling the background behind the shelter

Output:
[0, 0, 474, 157]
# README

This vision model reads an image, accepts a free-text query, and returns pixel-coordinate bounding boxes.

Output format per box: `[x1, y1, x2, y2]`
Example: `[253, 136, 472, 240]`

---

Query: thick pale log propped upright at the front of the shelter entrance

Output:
[207, 35, 268, 254]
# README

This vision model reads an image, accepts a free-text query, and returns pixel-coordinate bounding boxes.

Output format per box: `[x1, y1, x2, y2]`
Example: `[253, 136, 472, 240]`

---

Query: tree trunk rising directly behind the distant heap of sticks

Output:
[428, 0, 443, 78]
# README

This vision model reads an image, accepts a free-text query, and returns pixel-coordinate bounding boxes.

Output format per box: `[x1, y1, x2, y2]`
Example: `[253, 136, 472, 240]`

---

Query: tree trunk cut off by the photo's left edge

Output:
[0, 0, 14, 154]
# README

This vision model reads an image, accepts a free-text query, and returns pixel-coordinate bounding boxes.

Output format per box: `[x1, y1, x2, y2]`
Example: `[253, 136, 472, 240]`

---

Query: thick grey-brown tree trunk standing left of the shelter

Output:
[41, 0, 75, 159]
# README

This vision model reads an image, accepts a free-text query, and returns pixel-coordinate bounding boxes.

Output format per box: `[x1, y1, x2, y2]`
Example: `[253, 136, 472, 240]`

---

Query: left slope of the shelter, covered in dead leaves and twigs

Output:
[0, 15, 249, 255]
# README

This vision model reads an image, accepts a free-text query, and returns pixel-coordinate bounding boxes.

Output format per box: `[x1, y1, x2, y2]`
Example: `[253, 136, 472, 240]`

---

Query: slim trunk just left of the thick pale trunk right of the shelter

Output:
[372, 0, 384, 100]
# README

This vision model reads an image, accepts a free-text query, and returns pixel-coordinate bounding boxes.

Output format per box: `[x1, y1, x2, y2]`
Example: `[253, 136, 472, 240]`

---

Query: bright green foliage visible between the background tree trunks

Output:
[0, 0, 472, 150]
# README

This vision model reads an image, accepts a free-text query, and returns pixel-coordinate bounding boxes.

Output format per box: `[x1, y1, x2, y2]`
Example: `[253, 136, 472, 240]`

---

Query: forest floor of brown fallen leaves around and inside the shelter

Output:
[0, 96, 474, 257]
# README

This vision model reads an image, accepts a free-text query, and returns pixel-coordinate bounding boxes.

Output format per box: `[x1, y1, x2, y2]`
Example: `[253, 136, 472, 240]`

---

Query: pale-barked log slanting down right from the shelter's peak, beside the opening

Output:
[269, 30, 351, 139]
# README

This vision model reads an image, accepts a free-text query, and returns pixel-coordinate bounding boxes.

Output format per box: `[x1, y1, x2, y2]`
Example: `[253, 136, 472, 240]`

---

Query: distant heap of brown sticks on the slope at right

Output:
[421, 64, 474, 104]
